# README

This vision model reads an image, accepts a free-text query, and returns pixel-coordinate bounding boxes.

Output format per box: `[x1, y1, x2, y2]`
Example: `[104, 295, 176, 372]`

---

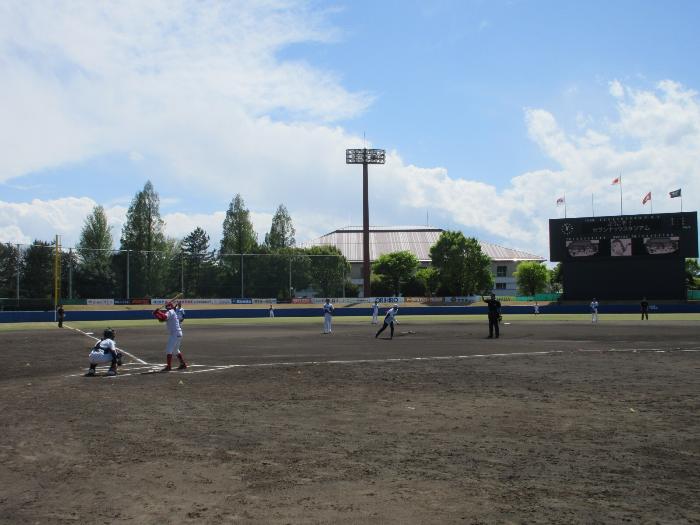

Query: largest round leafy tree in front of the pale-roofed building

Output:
[430, 231, 494, 295]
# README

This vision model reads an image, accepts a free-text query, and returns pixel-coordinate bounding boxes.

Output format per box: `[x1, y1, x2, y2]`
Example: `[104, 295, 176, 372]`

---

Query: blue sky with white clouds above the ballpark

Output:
[0, 0, 700, 258]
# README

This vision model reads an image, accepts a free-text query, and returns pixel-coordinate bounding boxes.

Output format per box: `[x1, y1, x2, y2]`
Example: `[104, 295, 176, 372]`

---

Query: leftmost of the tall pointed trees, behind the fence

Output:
[75, 206, 115, 297]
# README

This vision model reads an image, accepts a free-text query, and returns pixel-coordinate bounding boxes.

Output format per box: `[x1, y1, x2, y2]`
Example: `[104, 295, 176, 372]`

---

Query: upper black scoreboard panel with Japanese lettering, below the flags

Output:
[549, 212, 698, 262]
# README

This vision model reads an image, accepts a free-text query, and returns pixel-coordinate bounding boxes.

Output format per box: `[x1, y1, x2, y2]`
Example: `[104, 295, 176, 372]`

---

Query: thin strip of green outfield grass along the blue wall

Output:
[0, 313, 700, 332]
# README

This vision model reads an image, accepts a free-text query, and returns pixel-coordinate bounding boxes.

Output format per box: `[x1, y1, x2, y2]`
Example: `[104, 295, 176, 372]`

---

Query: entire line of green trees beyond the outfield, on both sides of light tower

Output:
[5, 181, 700, 300]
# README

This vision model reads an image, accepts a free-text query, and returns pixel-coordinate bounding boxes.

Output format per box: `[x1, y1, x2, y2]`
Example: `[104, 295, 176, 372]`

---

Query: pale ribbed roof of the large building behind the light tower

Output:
[304, 226, 546, 262]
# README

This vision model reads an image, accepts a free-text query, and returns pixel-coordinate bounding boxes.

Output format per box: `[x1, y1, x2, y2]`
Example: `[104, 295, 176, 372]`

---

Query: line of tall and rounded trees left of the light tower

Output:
[0, 181, 350, 299]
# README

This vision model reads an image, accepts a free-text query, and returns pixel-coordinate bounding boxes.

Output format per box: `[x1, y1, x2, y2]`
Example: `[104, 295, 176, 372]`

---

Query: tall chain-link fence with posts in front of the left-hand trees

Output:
[0, 242, 357, 309]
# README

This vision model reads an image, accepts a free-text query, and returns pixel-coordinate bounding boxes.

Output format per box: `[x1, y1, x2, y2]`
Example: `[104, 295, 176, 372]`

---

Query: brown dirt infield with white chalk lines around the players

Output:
[0, 321, 700, 524]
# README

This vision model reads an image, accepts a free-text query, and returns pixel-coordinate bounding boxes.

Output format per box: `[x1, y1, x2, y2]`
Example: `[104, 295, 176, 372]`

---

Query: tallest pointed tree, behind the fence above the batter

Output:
[121, 181, 167, 296]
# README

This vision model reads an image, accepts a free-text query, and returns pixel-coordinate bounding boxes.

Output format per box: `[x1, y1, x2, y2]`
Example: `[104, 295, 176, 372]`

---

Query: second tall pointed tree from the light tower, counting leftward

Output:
[219, 194, 258, 294]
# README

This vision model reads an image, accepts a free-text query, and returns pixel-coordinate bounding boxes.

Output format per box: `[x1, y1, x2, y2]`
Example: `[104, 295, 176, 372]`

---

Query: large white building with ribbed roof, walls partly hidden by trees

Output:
[305, 226, 545, 295]
